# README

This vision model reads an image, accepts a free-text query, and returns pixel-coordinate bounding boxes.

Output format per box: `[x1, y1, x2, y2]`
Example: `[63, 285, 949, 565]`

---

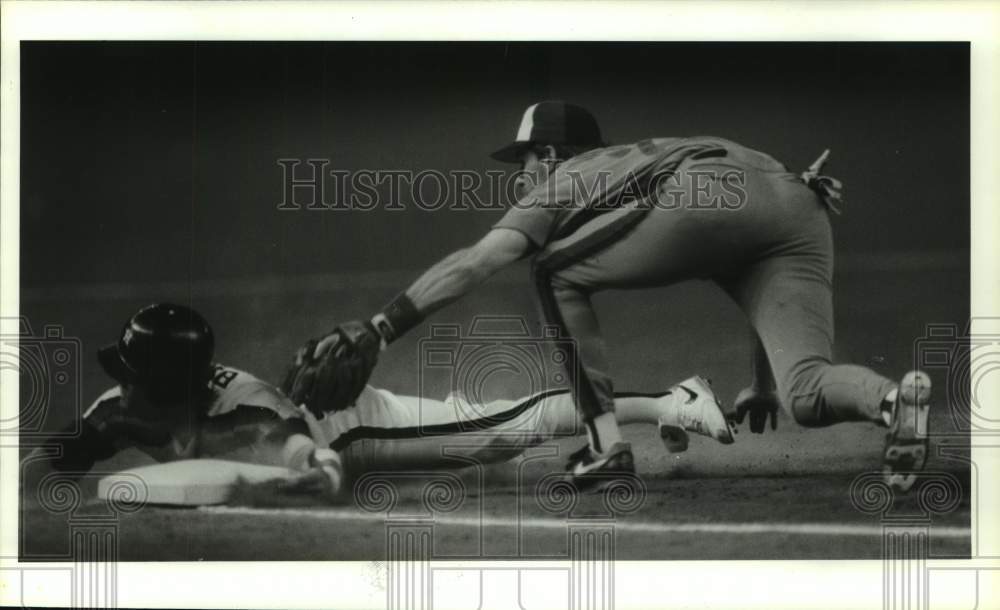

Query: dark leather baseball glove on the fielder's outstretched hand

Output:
[281, 320, 382, 417]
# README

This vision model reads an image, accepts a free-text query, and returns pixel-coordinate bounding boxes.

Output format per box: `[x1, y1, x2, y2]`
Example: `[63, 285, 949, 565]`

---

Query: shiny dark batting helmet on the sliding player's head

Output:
[97, 303, 215, 396]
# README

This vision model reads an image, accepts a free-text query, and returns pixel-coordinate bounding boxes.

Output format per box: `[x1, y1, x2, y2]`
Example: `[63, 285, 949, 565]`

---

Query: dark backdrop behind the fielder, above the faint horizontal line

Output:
[21, 42, 969, 284]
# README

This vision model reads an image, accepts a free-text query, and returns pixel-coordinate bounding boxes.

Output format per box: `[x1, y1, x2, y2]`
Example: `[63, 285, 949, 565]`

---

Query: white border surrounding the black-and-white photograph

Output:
[0, 1, 1000, 609]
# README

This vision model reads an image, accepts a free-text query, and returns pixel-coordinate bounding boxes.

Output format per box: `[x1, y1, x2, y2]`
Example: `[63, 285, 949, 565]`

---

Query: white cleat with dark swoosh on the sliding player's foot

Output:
[659, 376, 733, 453]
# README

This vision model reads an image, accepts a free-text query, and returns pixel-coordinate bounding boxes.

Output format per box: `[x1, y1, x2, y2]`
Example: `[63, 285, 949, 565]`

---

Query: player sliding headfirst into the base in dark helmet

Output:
[25, 304, 732, 496]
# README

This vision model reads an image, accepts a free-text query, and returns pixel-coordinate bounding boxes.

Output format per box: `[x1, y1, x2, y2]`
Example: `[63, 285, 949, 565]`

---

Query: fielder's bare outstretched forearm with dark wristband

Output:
[372, 228, 531, 343]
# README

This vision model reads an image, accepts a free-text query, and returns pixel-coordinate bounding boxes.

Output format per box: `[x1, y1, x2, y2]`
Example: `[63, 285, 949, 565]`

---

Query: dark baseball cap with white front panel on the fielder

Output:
[490, 100, 606, 163]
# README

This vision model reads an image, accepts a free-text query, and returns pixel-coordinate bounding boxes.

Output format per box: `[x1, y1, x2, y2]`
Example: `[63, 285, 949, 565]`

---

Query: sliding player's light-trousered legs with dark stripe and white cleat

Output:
[314, 377, 732, 475]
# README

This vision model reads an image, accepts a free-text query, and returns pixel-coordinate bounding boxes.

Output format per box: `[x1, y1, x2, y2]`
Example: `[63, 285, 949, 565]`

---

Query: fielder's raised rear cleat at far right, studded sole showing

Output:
[882, 371, 931, 491]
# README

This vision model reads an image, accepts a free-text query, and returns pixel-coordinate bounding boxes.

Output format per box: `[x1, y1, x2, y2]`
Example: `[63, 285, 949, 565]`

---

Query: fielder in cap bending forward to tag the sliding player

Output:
[344, 101, 930, 490]
